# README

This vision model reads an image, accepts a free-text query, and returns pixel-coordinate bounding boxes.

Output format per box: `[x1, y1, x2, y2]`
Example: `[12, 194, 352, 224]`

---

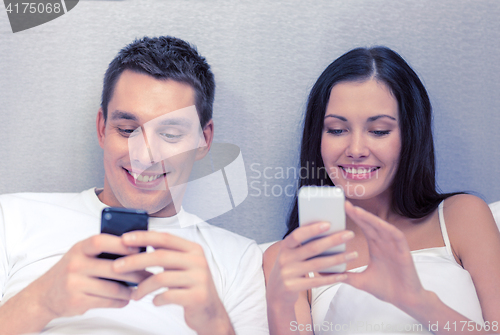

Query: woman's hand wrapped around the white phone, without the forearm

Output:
[265, 222, 357, 306]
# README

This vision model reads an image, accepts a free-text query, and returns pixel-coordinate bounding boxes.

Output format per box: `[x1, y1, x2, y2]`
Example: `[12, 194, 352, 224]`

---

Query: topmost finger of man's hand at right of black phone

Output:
[122, 231, 199, 252]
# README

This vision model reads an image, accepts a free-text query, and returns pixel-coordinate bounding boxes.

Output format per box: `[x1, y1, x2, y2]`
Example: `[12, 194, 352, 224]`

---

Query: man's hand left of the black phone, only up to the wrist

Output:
[38, 234, 147, 317]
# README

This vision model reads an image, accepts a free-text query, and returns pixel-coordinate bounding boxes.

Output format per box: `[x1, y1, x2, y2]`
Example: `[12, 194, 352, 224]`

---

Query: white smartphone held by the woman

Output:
[298, 186, 346, 272]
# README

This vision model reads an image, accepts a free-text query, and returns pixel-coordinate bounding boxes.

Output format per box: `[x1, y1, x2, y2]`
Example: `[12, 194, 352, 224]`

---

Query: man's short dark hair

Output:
[101, 36, 215, 128]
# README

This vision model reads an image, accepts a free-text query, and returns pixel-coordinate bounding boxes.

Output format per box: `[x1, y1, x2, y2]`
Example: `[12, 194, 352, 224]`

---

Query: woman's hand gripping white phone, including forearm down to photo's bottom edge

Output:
[264, 222, 357, 335]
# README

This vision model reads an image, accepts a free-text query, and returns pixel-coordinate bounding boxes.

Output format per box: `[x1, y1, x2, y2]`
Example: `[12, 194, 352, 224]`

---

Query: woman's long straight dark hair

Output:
[285, 47, 456, 236]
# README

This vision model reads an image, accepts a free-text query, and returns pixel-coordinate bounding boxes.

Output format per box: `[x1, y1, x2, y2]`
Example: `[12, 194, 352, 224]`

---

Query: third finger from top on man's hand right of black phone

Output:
[132, 271, 192, 300]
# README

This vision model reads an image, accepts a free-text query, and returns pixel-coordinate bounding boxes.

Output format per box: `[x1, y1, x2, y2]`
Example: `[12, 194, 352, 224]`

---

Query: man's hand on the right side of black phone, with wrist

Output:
[114, 231, 234, 335]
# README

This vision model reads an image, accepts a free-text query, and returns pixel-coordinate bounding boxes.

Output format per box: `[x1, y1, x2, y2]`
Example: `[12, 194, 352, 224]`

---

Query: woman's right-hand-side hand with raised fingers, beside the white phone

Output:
[344, 201, 427, 309]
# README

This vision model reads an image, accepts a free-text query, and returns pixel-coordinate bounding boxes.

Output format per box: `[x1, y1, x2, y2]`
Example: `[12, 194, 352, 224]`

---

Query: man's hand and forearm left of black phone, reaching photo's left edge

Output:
[0, 234, 150, 334]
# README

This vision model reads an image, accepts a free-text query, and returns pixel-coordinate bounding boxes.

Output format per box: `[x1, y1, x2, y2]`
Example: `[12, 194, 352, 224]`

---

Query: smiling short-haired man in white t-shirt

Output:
[0, 37, 268, 335]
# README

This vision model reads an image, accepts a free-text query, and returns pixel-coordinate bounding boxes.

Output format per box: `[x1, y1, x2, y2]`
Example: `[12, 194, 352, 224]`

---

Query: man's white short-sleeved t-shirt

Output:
[0, 189, 269, 335]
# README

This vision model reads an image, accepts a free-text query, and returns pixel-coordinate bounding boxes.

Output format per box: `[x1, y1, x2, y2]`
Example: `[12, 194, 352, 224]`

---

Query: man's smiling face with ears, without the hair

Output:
[97, 70, 213, 216]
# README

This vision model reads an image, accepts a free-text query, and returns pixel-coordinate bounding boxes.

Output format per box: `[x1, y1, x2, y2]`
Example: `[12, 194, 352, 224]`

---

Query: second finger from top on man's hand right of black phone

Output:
[113, 249, 193, 273]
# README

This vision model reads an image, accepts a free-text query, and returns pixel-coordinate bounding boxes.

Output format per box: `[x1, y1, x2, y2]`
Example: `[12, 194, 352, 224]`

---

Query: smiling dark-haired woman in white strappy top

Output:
[264, 47, 500, 334]
